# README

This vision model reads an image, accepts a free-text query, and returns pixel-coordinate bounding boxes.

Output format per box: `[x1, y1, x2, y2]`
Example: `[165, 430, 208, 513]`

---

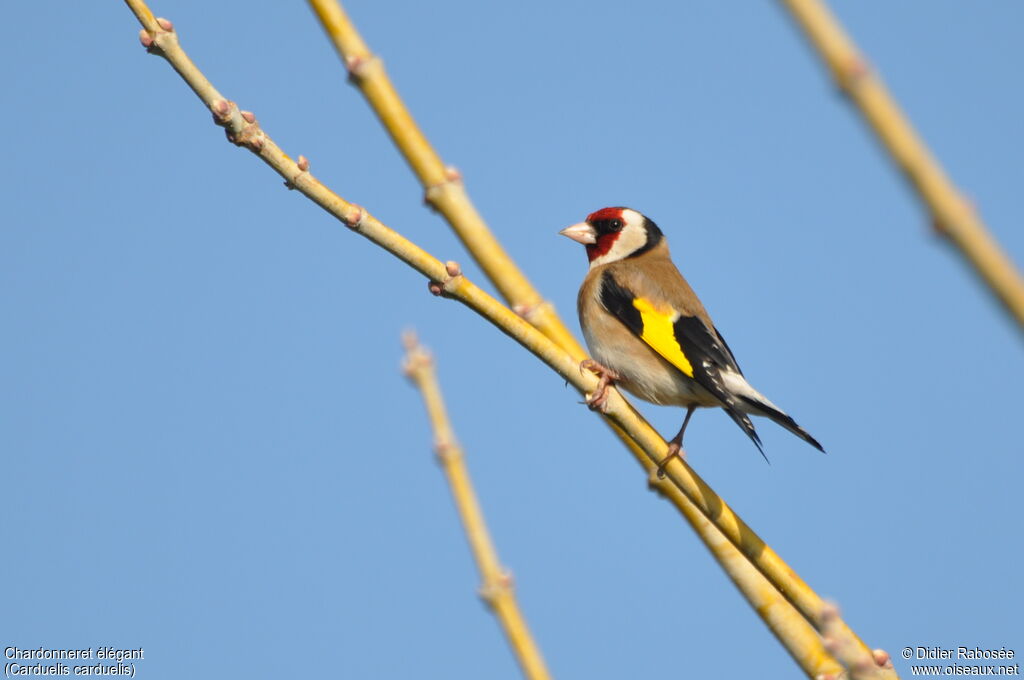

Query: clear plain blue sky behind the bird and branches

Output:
[0, 0, 1024, 678]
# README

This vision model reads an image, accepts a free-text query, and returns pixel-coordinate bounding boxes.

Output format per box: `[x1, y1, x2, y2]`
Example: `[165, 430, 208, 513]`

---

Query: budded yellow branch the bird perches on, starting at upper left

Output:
[125, 0, 896, 678]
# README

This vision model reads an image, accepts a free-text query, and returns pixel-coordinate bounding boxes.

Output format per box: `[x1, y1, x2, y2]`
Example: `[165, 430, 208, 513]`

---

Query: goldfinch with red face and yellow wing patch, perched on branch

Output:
[559, 207, 824, 476]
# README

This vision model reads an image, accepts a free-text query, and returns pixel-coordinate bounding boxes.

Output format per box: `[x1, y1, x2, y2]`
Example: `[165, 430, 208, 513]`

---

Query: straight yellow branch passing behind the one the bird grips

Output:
[309, 0, 840, 678]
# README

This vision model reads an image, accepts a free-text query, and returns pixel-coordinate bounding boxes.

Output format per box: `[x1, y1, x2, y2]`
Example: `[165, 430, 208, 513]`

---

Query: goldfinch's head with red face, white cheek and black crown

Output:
[559, 208, 662, 268]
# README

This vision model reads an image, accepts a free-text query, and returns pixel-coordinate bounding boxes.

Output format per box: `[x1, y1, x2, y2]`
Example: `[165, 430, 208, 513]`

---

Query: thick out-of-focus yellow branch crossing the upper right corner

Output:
[782, 0, 1024, 328]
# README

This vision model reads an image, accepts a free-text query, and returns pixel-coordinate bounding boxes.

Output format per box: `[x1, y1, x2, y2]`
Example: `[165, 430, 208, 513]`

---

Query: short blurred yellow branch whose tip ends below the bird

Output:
[404, 334, 551, 680]
